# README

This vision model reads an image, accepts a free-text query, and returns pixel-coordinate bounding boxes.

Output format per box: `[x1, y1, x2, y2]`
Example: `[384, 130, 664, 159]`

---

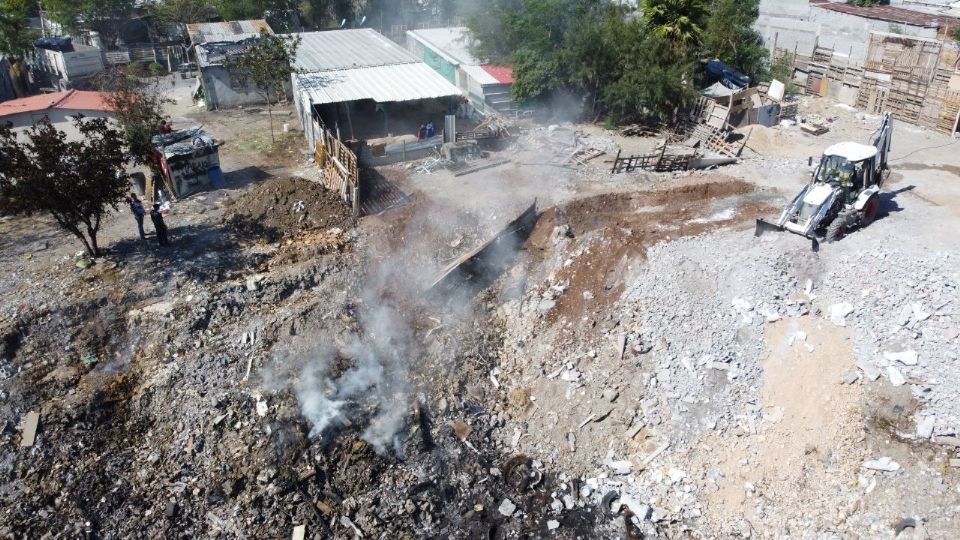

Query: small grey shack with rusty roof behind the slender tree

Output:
[187, 19, 273, 110]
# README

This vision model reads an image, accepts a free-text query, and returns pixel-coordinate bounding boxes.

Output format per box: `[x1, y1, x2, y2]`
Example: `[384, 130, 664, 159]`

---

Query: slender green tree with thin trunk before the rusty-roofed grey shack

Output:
[228, 30, 300, 143]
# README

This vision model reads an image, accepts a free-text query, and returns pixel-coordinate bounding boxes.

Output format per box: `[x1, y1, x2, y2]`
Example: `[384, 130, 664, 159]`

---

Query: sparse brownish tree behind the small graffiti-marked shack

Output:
[97, 69, 171, 169]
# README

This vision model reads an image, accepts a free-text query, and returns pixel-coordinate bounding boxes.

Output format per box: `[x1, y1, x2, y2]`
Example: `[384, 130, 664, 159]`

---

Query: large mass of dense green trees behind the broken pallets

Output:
[467, 0, 767, 121]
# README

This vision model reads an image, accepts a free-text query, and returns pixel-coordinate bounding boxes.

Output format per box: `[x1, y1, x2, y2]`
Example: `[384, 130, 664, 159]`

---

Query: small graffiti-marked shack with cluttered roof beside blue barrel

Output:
[147, 126, 223, 198]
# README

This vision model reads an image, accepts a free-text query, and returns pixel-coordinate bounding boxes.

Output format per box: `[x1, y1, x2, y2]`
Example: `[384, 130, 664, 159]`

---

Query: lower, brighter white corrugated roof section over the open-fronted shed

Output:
[294, 62, 460, 105]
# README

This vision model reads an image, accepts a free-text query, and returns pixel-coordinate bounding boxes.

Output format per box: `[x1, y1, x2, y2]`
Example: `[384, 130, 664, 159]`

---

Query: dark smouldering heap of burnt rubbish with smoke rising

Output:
[0, 185, 608, 538]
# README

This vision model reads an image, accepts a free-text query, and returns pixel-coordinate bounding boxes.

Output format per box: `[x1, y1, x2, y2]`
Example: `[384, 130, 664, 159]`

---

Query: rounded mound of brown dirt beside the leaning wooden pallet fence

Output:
[223, 177, 354, 242]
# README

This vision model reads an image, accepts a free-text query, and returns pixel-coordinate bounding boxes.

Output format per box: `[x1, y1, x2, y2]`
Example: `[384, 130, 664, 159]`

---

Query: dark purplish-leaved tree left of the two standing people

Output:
[0, 117, 130, 257]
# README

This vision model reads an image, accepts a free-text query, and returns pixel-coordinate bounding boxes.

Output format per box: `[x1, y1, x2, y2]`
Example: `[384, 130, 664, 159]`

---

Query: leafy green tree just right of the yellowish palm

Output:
[701, 0, 769, 78]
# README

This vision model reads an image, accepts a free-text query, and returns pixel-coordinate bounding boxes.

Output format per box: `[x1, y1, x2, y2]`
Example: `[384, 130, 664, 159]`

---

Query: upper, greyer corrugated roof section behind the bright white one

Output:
[296, 28, 417, 73]
